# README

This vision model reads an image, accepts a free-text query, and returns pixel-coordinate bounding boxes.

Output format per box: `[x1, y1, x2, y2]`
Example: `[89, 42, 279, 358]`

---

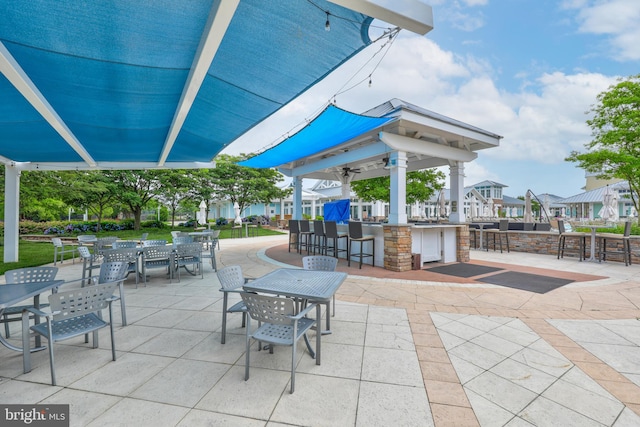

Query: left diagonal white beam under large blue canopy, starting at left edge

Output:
[0, 42, 96, 166]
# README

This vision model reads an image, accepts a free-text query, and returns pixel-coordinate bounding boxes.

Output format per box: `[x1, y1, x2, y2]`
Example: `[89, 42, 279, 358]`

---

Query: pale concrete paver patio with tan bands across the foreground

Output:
[0, 236, 640, 427]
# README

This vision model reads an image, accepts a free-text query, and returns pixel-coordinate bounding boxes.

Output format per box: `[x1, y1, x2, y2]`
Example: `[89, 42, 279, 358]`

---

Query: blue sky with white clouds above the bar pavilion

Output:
[224, 0, 640, 201]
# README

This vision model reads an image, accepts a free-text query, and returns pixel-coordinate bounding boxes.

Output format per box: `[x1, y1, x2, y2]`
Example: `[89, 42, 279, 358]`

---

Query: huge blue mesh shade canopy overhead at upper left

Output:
[0, 0, 371, 169]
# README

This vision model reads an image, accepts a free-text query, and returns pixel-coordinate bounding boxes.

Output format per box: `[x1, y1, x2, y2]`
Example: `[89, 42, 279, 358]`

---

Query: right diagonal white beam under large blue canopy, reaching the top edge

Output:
[158, 0, 240, 166]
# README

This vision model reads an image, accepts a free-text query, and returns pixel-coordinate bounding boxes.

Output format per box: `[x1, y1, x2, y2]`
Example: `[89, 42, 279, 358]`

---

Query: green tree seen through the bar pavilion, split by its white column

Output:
[351, 169, 445, 205]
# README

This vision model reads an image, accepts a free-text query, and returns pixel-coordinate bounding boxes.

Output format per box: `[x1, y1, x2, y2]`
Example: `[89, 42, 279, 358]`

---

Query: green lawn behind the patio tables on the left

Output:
[0, 226, 282, 274]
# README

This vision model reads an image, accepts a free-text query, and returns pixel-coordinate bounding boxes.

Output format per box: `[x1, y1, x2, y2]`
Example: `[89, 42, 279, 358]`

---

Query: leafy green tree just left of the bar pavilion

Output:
[209, 154, 287, 219]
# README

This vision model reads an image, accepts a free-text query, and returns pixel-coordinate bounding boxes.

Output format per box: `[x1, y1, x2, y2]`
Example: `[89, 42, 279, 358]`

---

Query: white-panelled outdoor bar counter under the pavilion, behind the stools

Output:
[338, 222, 466, 267]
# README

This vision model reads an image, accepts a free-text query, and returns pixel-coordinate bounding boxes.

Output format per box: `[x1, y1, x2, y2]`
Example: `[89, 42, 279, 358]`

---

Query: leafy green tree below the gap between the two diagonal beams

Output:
[105, 170, 165, 230]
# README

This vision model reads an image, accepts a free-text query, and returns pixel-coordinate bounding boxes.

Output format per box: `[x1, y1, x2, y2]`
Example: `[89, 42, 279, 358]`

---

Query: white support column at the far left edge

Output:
[4, 165, 20, 262]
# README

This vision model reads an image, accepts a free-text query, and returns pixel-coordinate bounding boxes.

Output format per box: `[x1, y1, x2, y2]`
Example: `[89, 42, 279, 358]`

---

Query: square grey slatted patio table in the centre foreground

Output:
[244, 268, 347, 365]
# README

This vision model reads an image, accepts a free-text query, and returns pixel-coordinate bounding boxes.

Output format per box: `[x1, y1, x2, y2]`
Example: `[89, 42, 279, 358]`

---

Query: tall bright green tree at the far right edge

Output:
[565, 74, 640, 222]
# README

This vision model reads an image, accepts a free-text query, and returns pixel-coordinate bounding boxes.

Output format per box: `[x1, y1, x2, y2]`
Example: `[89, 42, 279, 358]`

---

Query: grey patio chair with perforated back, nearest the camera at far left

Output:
[22, 283, 118, 385]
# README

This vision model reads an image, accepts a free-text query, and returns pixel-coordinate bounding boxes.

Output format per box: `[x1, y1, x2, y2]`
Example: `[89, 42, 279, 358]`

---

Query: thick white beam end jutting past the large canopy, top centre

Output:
[329, 0, 433, 35]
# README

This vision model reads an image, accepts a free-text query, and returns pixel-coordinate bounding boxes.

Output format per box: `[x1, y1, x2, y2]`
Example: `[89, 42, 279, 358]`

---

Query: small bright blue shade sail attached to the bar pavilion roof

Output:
[239, 105, 394, 168]
